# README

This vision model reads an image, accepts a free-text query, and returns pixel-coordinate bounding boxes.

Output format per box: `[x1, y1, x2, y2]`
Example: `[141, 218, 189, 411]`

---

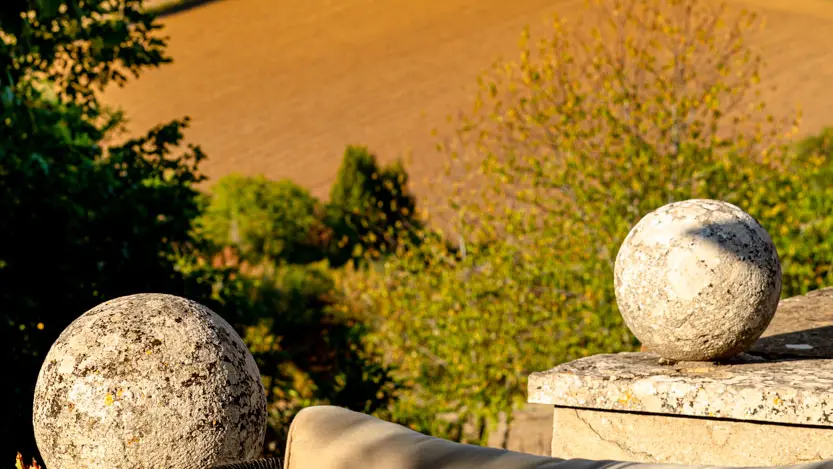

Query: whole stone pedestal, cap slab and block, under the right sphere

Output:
[529, 288, 833, 466]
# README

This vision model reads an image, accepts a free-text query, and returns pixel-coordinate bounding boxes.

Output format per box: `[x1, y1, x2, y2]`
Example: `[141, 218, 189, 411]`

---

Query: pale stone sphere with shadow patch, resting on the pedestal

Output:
[614, 199, 781, 361]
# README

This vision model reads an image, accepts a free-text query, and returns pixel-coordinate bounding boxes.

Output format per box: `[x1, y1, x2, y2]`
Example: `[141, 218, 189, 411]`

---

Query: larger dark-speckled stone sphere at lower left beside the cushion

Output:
[33, 294, 266, 469]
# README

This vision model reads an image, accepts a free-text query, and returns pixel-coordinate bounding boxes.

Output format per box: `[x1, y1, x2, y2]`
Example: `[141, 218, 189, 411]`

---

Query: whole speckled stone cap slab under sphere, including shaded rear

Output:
[528, 288, 833, 427]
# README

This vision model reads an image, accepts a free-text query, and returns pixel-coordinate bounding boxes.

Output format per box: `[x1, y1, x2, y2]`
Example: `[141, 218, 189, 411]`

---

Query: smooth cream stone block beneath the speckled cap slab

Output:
[550, 407, 833, 469]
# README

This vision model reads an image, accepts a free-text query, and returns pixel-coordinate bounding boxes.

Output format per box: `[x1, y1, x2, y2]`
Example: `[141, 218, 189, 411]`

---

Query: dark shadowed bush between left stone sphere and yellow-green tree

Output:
[179, 257, 398, 455]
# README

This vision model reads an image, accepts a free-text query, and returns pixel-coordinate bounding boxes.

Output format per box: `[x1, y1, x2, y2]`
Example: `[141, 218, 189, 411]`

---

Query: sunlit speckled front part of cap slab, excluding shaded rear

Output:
[529, 353, 833, 427]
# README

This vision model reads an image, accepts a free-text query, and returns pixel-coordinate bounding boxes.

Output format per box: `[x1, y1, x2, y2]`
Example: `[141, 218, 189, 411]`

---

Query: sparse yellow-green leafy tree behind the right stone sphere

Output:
[345, 0, 833, 441]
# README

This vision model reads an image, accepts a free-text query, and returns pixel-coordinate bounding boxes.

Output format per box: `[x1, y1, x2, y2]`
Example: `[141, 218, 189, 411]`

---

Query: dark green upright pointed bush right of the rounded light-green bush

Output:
[327, 146, 419, 265]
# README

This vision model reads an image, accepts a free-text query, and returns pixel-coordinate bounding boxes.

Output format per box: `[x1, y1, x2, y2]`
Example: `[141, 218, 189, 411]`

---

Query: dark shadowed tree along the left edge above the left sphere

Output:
[0, 0, 204, 454]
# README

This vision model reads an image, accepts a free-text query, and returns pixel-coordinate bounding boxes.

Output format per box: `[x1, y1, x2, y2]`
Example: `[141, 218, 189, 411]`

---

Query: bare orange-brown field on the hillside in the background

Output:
[106, 0, 833, 196]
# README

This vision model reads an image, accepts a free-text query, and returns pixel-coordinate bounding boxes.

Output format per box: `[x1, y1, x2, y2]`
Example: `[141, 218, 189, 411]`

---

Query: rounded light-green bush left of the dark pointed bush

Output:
[197, 175, 328, 264]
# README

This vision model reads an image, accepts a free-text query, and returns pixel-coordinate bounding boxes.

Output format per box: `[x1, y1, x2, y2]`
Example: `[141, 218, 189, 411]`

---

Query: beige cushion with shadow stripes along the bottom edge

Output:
[284, 406, 833, 469]
